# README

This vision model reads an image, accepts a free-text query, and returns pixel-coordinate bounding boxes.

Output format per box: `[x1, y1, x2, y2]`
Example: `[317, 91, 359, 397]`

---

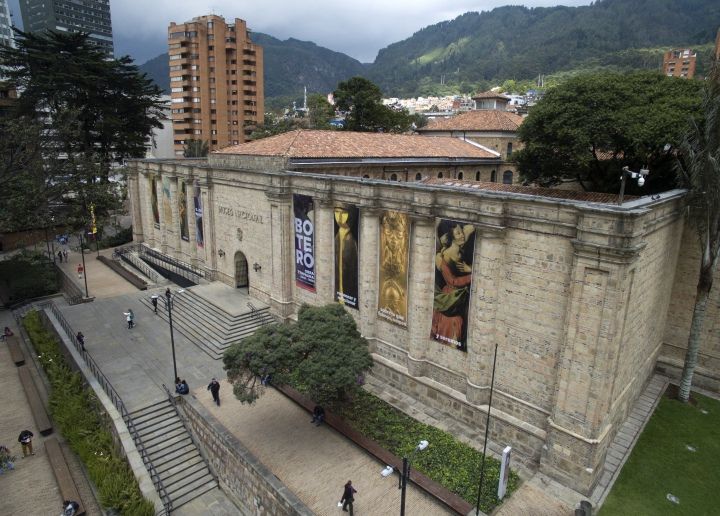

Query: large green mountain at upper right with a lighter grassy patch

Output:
[368, 0, 720, 96]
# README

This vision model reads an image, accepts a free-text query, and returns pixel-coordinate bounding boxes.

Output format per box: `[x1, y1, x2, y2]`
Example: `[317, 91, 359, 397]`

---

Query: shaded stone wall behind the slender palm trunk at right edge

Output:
[657, 224, 720, 392]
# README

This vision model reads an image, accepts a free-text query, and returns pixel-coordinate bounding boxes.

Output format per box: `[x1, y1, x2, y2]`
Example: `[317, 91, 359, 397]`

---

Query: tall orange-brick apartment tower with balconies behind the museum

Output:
[168, 15, 265, 156]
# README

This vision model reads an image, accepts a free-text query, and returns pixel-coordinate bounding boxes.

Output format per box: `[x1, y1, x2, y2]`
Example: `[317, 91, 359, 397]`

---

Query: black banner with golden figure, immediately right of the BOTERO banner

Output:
[334, 204, 360, 309]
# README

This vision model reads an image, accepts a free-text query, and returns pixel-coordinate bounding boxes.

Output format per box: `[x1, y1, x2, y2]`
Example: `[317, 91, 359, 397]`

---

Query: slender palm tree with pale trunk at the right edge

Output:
[677, 61, 720, 402]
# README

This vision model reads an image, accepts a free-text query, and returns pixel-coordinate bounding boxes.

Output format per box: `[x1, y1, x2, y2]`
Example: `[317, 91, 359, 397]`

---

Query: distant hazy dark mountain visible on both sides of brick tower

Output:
[139, 32, 365, 102]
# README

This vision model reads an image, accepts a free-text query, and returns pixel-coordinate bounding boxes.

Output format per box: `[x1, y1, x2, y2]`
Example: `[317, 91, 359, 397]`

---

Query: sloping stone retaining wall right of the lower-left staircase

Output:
[178, 397, 313, 516]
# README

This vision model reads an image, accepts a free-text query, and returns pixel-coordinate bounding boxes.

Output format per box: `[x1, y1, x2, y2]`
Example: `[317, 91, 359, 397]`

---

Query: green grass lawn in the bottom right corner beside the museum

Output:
[600, 394, 720, 516]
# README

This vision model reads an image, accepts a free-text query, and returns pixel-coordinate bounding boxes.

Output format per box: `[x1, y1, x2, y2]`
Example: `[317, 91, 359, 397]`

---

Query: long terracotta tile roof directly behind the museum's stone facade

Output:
[216, 129, 498, 159]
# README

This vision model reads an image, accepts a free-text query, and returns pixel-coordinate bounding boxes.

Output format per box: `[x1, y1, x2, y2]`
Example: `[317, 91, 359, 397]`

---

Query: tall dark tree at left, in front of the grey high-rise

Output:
[0, 31, 163, 225]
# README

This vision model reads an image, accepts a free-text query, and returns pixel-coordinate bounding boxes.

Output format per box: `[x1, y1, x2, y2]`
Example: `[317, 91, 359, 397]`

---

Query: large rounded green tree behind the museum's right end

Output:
[514, 72, 702, 193]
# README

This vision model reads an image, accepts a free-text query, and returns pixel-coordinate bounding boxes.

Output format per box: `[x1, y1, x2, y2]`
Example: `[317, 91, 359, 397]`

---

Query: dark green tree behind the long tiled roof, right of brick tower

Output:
[333, 77, 416, 133]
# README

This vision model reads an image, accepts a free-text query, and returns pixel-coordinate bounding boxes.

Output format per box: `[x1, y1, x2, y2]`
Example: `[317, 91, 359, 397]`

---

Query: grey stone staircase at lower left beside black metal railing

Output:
[130, 399, 218, 510]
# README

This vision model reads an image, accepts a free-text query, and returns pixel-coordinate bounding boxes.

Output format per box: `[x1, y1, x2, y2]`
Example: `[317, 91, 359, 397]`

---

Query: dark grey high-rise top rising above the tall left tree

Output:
[20, 0, 113, 56]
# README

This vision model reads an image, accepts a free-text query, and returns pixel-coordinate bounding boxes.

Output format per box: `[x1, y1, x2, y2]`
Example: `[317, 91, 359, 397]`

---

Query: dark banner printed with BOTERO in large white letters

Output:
[293, 194, 315, 292]
